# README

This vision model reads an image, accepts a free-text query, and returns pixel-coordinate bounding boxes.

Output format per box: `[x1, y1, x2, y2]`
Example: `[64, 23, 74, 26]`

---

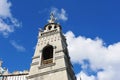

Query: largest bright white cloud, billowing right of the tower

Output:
[65, 31, 120, 80]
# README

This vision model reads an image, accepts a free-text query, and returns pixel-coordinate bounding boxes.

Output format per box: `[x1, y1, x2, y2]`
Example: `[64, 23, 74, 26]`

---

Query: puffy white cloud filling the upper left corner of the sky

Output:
[0, 0, 21, 36]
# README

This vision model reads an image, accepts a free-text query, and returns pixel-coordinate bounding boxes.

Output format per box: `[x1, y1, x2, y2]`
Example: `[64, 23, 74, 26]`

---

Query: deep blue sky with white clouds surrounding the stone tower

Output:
[0, 0, 120, 80]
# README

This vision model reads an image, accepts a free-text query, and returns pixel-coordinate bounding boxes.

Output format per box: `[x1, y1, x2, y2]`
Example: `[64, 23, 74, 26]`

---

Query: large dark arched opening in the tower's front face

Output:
[42, 45, 53, 64]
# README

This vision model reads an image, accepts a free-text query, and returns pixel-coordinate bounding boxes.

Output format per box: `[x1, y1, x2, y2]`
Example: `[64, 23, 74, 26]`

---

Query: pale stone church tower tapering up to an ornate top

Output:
[27, 13, 76, 80]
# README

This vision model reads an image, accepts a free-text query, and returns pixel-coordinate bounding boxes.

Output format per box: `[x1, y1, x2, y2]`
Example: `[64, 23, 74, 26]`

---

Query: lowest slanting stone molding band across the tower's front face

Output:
[27, 67, 66, 79]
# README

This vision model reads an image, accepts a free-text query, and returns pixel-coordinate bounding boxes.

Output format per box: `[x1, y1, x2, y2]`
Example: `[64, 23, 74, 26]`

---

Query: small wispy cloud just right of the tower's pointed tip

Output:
[51, 7, 68, 21]
